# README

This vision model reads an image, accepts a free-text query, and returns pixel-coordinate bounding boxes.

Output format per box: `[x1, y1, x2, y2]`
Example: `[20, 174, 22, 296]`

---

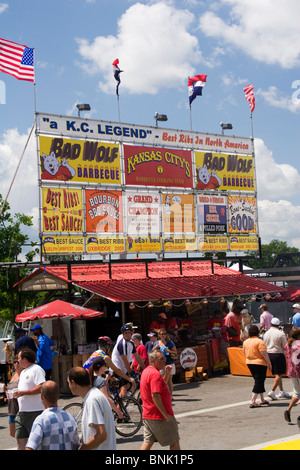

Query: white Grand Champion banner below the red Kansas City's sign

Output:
[125, 191, 161, 235]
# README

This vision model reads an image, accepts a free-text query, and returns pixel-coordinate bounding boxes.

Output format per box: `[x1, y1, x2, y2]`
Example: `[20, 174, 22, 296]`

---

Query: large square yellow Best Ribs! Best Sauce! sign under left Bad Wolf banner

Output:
[42, 188, 83, 233]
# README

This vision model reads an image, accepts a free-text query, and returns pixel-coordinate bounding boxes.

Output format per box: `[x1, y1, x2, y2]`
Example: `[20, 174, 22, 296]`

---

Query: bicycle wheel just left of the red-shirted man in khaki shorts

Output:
[114, 397, 143, 437]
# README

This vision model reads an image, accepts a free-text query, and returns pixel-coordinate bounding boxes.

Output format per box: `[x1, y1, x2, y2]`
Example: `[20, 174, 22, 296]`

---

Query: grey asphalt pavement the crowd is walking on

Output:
[0, 374, 300, 455]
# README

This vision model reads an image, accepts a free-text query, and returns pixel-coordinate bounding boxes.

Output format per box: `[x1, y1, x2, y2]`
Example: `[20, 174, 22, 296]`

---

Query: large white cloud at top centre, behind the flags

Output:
[77, 2, 203, 94]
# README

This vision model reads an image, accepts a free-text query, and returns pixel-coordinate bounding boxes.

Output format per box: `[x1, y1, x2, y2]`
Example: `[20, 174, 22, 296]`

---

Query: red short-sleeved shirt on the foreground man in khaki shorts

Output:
[140, 366, 174, 419]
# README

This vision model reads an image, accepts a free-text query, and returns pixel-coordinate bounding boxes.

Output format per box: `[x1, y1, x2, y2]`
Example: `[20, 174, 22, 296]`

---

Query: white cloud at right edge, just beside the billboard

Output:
[255, 139, 300, 199]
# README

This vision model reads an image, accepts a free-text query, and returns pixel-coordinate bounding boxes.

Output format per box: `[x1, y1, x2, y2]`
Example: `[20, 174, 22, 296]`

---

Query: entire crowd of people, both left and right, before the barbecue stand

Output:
[6, 302, 300, 450]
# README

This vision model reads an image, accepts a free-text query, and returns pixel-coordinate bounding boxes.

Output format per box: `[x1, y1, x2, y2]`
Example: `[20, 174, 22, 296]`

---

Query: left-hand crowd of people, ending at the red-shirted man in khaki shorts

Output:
[6, 323, 180, 450]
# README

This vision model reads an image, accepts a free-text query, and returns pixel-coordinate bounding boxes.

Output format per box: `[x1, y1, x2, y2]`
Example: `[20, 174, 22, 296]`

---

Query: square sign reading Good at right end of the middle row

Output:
[228, 196, 257, 234]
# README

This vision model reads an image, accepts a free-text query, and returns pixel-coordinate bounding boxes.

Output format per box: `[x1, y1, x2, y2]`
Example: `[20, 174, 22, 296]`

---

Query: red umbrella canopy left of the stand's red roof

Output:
[15, 300, 103, 322]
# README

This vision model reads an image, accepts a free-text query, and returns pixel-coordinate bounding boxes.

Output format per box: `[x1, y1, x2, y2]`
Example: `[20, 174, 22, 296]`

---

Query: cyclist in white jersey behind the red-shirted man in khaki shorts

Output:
[111, 324, 145, 396]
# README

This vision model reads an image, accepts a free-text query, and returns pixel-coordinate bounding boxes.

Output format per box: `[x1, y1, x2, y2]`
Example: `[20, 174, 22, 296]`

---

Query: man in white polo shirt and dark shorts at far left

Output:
[13, 348, 45, 450]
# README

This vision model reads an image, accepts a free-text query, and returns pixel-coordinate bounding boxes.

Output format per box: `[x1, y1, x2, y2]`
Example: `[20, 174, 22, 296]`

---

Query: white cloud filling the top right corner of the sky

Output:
[199, 0, 300, 68]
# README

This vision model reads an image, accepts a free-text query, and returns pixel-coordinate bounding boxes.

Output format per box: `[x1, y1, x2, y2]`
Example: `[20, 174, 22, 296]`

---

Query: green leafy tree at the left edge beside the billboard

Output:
[0, 195, 38, 321]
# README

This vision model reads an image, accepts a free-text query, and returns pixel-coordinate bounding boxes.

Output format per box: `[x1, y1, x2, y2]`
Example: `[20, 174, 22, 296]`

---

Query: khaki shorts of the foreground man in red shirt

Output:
[143, 416, 179, 447]
